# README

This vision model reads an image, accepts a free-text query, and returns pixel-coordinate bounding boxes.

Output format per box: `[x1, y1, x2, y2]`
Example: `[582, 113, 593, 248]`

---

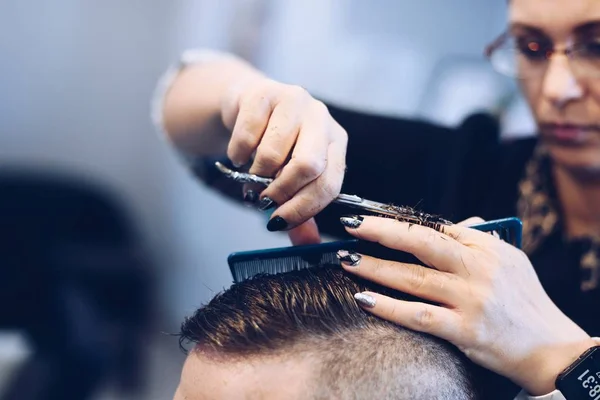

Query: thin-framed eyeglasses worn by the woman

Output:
[485, 32, 600, 79]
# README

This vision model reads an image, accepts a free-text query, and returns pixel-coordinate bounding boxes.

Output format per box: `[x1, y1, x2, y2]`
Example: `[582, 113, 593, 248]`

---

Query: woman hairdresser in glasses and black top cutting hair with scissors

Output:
[155, 0, 600, 400]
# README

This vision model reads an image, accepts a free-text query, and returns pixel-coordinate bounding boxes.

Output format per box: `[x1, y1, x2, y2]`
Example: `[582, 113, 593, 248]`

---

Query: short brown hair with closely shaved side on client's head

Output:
[180, 266, 475, 400]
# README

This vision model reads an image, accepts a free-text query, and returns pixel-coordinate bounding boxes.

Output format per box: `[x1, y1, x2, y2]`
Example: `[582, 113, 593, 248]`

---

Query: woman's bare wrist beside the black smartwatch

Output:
[516, 335, 598, 396]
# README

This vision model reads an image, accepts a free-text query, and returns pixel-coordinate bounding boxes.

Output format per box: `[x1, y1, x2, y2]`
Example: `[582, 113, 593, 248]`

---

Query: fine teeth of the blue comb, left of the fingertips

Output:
[230, 252, 340, 282]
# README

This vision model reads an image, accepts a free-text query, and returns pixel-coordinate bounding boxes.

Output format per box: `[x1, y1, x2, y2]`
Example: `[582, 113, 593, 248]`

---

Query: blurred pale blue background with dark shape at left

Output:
[0, 0, 533, 400]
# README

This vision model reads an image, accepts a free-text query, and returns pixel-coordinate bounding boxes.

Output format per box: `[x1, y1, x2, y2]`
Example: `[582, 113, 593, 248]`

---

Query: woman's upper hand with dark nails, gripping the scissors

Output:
[221, 77, 348, 244]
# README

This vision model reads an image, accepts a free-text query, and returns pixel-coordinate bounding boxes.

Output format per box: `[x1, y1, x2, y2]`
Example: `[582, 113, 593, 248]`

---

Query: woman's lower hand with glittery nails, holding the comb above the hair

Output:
[342, 216, 595, 395]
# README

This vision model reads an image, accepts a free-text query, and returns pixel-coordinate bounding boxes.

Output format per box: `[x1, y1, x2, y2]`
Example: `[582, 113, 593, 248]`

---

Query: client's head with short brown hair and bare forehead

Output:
[175, 266, 474, 400]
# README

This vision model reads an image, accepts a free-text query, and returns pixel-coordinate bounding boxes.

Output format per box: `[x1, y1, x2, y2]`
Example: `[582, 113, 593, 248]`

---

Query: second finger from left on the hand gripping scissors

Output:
[249, 99, 303, 177]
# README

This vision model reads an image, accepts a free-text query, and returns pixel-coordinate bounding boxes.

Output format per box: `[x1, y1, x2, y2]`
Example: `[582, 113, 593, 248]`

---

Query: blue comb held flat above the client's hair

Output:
[227, 217, 523, 283]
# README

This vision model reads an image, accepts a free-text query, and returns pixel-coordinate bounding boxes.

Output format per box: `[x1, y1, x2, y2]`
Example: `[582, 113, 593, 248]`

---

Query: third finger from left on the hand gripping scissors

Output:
[261, 103, 330, 204]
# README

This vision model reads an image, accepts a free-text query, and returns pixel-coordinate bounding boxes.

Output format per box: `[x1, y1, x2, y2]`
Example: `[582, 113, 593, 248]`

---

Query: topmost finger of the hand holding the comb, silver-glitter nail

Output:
[341, 216, 464, 273]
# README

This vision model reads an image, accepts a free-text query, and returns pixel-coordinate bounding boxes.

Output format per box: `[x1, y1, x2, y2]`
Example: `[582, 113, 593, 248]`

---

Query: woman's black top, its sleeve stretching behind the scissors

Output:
[199, 104, 600, 399]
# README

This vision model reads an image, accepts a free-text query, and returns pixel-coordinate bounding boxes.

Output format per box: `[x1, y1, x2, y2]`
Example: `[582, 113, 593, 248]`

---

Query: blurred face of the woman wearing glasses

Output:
[510, 0, 600, 177]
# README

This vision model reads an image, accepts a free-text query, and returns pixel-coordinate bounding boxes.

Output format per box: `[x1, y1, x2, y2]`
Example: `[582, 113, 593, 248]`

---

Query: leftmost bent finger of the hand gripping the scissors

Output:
[227, 92, 274, 166]
